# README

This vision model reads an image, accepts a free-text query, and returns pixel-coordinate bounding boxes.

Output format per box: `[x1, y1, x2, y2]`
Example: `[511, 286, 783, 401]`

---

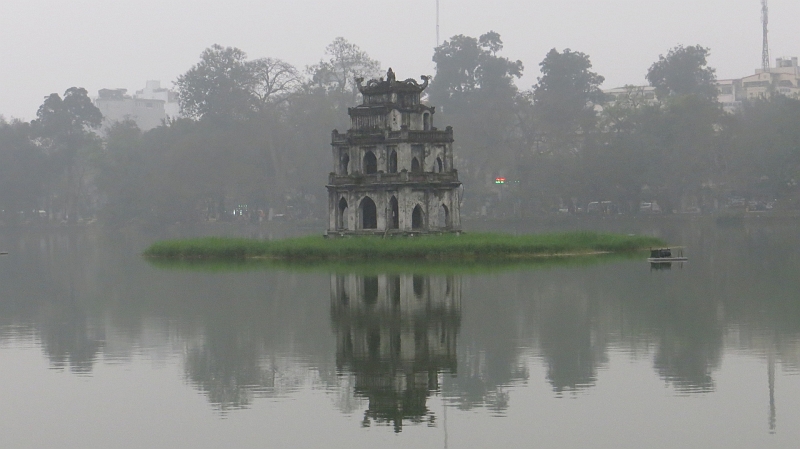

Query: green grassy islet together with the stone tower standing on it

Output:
[144, 69, 664, 264]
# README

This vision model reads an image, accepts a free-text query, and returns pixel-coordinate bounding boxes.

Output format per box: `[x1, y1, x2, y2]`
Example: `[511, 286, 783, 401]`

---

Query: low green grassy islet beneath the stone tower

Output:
[144, 232, 664, 262]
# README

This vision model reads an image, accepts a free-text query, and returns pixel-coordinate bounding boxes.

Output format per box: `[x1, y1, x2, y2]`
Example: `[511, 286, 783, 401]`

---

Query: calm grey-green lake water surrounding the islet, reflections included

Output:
[0, 216, 800, 449]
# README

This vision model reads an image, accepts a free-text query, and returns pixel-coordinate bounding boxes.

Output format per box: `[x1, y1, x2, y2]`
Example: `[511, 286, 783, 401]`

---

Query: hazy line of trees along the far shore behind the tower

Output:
[0, 32, 800, 226]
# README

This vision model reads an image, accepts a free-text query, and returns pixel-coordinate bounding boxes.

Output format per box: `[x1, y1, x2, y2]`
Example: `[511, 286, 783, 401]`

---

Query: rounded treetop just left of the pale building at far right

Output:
[647, 45, 719, 101]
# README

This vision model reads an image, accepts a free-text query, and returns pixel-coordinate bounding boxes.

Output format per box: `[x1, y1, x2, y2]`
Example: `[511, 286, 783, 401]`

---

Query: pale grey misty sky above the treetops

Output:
[0, 0, 800, 120]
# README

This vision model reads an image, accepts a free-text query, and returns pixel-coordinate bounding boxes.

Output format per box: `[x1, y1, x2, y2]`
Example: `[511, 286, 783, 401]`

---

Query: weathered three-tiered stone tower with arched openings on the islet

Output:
[326, 69, 461, 237]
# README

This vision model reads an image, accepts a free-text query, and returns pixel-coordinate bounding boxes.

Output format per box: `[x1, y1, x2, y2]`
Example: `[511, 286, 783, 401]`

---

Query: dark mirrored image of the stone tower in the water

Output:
[331, 274, 461, 432]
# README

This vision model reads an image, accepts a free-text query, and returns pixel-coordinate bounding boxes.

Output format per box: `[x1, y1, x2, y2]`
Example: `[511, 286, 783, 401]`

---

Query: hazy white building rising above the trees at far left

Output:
[94, 81, 180, 131]
